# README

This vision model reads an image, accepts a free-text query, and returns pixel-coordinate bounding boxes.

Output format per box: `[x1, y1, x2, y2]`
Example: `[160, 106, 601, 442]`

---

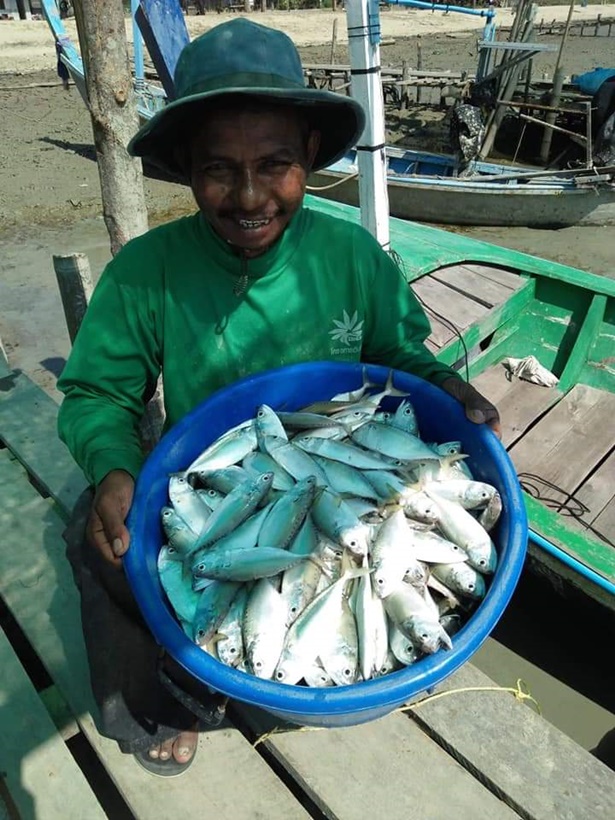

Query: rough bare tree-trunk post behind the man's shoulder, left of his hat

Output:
[74, 0, 147, 255]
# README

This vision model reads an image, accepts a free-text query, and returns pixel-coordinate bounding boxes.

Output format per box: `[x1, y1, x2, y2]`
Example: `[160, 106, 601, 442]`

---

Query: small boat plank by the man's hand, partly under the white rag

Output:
[472, 364, 562, 448]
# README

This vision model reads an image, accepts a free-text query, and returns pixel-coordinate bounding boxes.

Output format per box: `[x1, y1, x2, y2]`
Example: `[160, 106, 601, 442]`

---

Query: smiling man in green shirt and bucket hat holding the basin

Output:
[59, 19, 498, 775]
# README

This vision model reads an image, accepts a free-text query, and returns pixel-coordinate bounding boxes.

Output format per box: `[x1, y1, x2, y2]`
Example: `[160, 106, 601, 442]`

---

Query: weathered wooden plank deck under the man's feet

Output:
[0, 274, 615, 820]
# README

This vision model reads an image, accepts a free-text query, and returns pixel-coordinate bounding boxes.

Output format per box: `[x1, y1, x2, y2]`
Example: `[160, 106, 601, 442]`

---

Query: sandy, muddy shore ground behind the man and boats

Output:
[0, 5, 615, 397]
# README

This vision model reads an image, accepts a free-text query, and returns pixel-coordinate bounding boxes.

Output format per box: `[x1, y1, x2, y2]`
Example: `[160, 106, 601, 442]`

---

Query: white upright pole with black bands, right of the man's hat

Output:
[346, 0, 389, 250]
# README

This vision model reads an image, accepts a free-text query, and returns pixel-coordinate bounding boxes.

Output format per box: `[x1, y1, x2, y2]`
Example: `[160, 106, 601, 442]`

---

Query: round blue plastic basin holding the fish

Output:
[124, 362, 527, 726]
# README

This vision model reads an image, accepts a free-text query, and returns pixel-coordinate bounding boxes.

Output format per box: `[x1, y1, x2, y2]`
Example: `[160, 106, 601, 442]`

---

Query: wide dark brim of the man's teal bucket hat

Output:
[128, 88, 365, 177]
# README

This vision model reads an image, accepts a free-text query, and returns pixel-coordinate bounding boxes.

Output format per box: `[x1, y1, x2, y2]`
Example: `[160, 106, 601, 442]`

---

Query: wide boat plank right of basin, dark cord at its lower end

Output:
[510, 384, 615, 502]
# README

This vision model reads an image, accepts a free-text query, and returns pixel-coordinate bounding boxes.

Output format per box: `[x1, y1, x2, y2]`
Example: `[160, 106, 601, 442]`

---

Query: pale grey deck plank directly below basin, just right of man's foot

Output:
[236, 707, 518, 820]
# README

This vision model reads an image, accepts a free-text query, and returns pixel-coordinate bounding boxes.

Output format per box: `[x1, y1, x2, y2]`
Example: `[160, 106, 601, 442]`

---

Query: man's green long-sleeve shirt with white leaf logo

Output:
[58, 207, 454, 484]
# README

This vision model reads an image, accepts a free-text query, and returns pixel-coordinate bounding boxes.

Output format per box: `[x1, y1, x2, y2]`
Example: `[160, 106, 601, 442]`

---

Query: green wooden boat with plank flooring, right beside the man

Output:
[309, 197, 615, 610]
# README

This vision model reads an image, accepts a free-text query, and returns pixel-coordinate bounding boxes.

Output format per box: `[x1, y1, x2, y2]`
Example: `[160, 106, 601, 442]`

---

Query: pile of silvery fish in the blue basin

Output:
[158, 374, 501, 686]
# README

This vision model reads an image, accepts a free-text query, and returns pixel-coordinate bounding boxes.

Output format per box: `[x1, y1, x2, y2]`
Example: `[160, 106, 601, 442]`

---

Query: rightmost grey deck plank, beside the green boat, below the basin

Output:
[410, 663, 615, 820]
